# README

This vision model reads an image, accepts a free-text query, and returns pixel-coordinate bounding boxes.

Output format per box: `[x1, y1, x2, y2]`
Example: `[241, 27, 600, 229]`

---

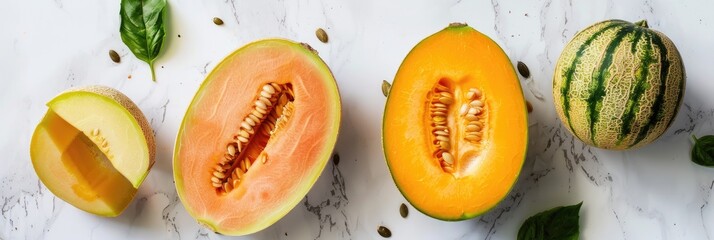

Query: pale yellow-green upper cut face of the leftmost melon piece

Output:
[47, 91, 153, 188]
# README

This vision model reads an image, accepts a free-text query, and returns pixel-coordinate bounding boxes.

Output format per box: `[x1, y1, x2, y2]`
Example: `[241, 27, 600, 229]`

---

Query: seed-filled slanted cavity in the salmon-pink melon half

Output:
[210, 83, 294, 194]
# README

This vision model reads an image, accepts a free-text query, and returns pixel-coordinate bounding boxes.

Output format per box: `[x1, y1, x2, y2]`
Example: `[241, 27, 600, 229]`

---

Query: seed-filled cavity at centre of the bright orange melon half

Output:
[426, 78, 487, 176]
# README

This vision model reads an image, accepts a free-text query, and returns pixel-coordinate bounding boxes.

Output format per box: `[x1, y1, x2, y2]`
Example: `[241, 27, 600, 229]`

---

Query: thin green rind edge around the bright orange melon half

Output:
[382, 23, 528, 222]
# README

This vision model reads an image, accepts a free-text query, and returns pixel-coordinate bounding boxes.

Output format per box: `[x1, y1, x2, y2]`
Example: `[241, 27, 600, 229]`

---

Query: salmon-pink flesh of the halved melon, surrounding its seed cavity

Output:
[174, 39, 340, 235]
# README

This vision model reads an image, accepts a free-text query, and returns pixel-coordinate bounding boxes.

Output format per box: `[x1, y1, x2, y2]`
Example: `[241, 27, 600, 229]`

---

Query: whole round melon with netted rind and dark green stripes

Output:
[553, 20, 685, 150]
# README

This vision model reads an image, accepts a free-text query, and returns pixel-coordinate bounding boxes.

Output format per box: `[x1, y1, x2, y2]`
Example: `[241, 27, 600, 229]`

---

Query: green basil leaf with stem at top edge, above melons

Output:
[119, 0, 166, 81]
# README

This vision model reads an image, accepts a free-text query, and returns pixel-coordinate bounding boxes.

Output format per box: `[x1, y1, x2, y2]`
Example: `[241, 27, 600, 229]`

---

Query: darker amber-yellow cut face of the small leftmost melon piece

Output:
[31, 110, 136, 217]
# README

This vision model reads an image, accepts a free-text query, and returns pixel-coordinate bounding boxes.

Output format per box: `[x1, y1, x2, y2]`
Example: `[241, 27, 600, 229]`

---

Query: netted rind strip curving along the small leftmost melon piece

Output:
[47, 85, 156, 189]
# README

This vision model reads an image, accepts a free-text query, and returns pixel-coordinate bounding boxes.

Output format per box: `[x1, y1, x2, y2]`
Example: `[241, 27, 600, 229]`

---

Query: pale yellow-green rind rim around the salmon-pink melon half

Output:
[173, 38, 342, 236]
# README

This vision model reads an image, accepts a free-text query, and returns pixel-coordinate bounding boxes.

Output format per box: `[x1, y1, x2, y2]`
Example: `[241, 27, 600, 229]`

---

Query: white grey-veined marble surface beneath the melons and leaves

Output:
[0, 0, 714, 239]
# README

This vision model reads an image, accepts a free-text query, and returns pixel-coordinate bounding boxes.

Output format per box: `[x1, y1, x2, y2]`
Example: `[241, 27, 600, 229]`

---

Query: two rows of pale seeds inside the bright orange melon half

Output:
[429, 83, 484, 173]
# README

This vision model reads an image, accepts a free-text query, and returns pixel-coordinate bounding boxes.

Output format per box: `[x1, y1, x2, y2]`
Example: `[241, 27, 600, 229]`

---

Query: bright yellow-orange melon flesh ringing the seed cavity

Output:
[383, 26, 528, 220]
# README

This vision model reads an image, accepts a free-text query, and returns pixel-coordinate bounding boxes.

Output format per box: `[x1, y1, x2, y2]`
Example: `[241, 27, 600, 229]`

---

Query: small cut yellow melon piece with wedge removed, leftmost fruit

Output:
[30, 86, 155, 216]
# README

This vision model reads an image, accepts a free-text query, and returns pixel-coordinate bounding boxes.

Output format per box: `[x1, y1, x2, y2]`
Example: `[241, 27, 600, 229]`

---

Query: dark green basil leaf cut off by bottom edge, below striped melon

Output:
[517, 202, 583, 240]
